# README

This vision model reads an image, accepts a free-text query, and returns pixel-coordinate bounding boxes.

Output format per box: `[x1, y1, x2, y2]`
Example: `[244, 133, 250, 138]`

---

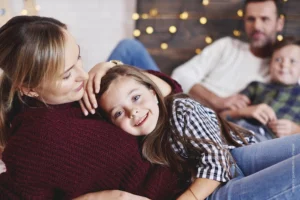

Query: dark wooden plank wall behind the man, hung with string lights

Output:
[136, 0, 300, 74]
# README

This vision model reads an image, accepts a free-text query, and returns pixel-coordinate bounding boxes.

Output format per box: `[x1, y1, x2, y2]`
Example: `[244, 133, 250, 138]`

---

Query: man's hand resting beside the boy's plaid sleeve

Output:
[215, 94, 250, 111]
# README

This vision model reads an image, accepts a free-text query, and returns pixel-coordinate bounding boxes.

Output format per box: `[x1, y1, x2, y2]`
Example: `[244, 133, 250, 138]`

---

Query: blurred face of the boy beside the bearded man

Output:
[270, 44, 300, 85]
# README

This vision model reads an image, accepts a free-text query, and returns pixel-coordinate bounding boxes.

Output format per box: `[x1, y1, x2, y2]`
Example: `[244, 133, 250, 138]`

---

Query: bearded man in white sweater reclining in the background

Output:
[172, 0, 284, 111]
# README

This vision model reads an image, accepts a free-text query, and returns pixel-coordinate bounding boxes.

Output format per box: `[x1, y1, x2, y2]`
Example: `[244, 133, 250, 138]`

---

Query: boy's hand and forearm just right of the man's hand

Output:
[237, 103, 277, 125]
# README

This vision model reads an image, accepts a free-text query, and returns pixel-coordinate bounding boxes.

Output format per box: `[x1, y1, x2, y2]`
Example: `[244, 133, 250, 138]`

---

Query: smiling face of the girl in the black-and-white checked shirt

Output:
[99, 77, 159, 136]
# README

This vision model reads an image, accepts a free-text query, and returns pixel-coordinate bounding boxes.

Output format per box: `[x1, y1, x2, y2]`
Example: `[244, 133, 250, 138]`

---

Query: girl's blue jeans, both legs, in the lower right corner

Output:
[207, 134, 300, 200]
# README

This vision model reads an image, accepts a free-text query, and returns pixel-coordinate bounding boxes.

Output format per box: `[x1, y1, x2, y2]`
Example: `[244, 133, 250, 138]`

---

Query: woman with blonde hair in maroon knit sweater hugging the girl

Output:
[0, 16, 185, 199]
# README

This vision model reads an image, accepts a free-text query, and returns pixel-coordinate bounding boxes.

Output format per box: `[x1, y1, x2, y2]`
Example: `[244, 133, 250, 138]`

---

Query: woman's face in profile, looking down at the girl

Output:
[35, 31, 88, 105]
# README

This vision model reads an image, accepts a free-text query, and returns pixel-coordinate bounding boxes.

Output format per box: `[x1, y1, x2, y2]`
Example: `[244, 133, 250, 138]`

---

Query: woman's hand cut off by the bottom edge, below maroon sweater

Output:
[73, 190, 150, 200]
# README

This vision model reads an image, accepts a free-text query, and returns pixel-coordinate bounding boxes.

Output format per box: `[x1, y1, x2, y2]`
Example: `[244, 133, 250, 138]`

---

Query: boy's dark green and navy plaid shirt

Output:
[241, 81, 300, 124]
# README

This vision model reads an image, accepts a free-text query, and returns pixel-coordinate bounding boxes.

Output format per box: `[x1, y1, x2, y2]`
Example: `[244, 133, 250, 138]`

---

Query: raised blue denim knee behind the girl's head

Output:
[107, 39, 160, 71]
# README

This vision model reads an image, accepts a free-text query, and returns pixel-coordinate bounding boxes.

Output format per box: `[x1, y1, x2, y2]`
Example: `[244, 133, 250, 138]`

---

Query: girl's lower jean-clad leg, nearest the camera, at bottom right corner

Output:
[207, 155, 300, 200]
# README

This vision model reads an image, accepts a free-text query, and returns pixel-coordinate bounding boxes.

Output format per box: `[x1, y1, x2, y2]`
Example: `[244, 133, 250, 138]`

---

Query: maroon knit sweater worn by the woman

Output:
[0, 74, 185, 200]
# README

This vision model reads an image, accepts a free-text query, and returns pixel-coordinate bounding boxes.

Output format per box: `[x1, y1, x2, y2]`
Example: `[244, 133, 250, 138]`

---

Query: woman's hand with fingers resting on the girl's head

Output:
[79, 62, 116, 116]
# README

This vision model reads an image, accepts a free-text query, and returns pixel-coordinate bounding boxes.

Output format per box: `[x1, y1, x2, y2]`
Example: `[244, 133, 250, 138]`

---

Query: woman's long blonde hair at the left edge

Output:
[0, 16, 66, 147]
